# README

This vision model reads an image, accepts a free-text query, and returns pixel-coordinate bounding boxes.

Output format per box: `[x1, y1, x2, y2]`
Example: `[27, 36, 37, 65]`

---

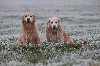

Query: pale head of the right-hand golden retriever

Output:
[47, 17, 60, 31]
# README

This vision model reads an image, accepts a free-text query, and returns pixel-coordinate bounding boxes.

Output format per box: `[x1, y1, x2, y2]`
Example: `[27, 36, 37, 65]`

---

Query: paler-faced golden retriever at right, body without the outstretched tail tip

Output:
[46, 17, 73, 44]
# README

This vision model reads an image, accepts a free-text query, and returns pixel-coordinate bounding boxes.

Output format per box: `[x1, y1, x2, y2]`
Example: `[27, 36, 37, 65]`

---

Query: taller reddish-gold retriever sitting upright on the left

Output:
[17, 12, 40, 45]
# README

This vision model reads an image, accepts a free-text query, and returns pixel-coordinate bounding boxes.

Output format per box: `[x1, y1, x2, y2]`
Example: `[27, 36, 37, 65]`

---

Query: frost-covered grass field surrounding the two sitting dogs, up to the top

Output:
[0, 0, 100, 66]
